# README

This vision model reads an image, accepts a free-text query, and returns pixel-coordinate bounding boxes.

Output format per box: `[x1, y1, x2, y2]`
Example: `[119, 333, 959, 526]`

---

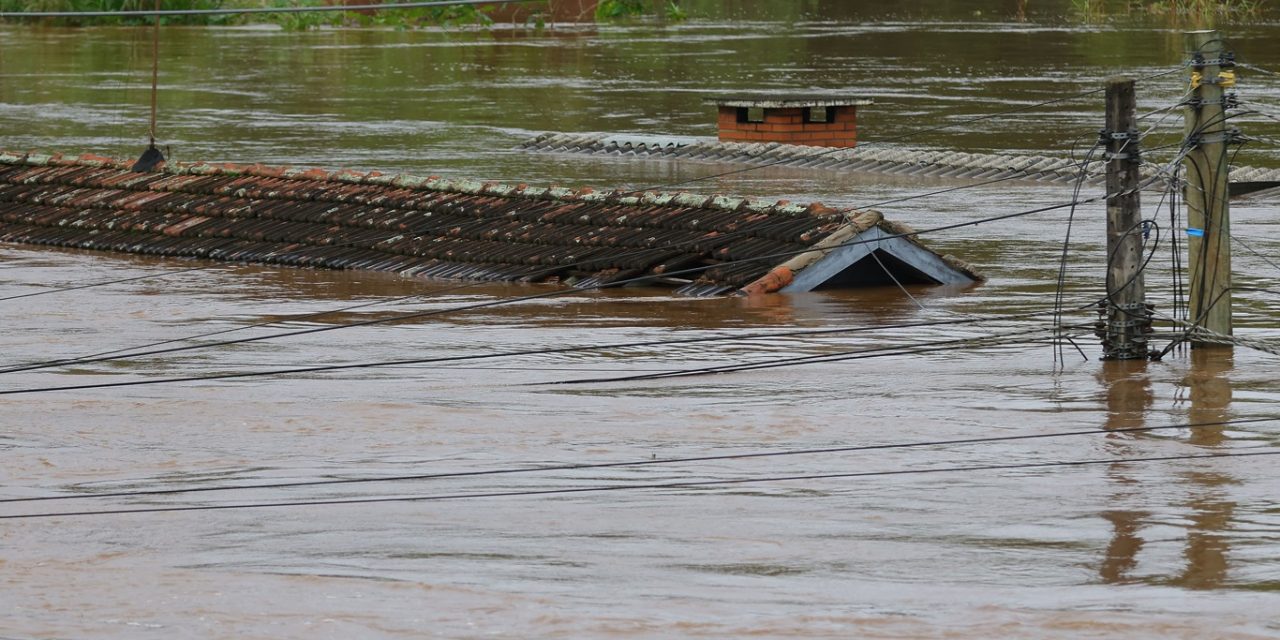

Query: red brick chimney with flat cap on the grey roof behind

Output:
[707, 95, 873, 147]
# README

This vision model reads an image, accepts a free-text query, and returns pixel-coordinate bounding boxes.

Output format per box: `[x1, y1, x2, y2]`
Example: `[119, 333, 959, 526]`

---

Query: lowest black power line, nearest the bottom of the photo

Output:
[0, 451, 1280, 520]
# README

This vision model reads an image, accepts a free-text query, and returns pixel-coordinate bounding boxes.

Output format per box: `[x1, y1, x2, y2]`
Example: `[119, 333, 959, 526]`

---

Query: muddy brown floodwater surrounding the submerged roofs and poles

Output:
[0, 6, 1280, 639]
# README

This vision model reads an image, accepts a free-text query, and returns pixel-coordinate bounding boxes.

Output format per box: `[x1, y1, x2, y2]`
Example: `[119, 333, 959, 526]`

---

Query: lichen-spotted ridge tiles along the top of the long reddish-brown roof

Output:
[0, 150, 861, 218]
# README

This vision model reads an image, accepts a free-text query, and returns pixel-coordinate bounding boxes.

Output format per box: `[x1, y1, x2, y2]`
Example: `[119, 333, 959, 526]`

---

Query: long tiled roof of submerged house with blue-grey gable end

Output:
[0, 152, 980, 296]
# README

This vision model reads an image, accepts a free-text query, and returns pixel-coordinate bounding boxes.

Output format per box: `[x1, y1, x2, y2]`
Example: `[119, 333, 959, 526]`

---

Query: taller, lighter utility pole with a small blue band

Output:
[1184, 31, 1235, 348]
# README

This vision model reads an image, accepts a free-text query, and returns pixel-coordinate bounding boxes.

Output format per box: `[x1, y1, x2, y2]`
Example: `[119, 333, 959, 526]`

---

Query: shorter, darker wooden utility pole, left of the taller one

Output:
[1098, 78, 1151, 360]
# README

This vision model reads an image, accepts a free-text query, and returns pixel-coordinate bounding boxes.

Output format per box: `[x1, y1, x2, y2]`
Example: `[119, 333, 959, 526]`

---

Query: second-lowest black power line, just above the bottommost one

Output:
[0, 417, 1280, 503]
